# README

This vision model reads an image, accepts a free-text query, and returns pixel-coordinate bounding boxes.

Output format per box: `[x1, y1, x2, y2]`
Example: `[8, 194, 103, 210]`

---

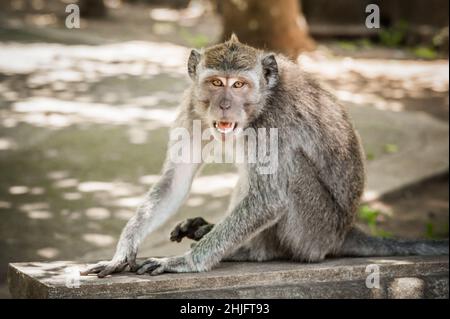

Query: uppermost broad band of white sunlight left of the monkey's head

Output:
[0, 41, 189, 75]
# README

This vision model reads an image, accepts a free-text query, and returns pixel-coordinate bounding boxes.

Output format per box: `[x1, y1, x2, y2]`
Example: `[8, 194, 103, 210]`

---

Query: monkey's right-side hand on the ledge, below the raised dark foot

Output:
[136, 253, 201, 276]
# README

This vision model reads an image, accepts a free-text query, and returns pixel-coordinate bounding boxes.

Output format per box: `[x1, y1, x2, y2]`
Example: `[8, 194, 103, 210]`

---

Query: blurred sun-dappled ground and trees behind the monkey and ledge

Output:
[0, 0, 449, 298]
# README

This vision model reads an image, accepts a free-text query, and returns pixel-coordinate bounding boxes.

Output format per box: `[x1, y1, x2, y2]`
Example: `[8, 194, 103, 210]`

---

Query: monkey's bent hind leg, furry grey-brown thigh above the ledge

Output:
[277, 166, 352, 262]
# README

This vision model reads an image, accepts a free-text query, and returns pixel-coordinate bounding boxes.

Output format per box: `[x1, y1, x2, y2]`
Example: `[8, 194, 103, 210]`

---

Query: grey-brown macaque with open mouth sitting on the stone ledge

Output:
[81, 35, 448, 278]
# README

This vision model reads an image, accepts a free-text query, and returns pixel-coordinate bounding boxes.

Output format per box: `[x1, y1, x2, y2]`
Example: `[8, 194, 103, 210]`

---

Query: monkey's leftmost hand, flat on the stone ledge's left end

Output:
[80, 250, 137, 278]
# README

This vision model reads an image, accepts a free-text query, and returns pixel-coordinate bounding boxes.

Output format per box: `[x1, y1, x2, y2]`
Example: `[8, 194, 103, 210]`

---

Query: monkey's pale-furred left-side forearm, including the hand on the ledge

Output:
[81, 156, 200, 277]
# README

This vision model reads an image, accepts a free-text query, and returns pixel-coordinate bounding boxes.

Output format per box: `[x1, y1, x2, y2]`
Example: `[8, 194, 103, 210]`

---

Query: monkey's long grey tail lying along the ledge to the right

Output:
[338, 228, 449, 257]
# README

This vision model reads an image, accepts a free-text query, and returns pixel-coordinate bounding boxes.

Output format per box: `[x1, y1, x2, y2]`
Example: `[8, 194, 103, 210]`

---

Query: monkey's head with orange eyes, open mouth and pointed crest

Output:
[188, 35, 278, 139]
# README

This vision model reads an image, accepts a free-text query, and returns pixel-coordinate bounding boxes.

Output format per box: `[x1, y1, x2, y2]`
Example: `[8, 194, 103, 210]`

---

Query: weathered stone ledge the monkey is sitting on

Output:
[8, 256, 449, 298]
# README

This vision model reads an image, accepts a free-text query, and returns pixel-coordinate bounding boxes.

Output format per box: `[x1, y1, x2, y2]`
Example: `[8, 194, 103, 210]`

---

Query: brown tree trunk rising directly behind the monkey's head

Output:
[221, 0, 314, 58]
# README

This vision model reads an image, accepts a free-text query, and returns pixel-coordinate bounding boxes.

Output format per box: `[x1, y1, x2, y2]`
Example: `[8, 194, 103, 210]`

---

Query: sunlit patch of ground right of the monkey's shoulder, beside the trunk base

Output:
[298, 54, 449, 112]
